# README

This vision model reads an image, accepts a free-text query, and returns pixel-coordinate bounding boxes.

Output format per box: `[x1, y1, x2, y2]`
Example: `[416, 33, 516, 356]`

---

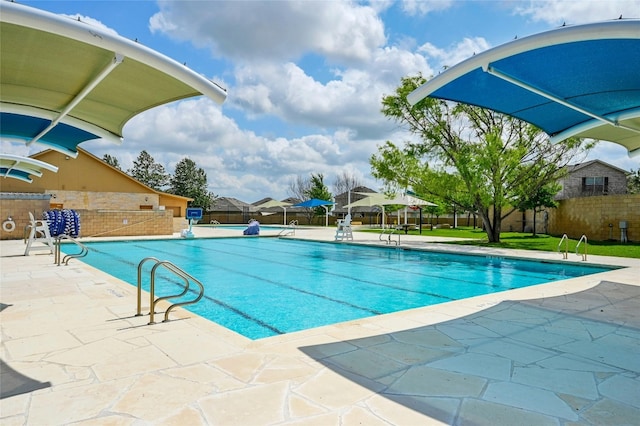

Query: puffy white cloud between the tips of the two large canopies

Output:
[228, 47, 431, 138]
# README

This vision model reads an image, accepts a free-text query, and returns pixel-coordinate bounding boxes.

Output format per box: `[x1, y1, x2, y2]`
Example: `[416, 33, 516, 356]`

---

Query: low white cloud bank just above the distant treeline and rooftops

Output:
[77, 98, 382, 202]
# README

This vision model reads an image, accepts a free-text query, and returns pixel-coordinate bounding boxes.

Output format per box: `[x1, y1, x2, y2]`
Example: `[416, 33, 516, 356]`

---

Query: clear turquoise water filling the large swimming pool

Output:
[74, 238, 609, 339]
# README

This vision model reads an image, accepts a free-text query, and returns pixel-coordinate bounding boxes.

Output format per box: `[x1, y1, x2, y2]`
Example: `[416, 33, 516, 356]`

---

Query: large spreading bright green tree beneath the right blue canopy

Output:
[371, 76, 585, 242]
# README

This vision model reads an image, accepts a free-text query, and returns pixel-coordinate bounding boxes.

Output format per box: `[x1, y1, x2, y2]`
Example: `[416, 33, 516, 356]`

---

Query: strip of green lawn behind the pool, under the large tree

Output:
[366, 227, 640, 259]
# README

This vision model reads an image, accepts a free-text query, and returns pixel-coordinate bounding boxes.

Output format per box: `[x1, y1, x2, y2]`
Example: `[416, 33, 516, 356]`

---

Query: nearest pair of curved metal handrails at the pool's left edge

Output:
[136, 257, 204, 325]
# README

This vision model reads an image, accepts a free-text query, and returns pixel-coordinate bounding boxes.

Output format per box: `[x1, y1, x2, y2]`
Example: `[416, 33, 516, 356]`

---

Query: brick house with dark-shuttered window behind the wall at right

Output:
[555, 160, 628, 200]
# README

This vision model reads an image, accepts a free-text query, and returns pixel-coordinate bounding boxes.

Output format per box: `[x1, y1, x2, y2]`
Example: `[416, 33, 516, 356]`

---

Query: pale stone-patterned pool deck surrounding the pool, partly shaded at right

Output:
[0, 227, 640, 426]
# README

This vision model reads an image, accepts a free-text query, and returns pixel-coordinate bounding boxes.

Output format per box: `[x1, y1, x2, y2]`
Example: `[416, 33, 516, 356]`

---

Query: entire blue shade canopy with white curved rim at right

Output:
[407, 19, 640, 156]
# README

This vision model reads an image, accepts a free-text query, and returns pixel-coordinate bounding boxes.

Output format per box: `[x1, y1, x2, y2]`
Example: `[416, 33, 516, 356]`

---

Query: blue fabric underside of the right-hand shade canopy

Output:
[431, 39, 640, 135]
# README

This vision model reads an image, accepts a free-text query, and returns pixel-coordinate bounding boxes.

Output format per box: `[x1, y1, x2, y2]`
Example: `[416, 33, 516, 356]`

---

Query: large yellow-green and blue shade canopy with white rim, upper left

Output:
[0, 1, 226, 157]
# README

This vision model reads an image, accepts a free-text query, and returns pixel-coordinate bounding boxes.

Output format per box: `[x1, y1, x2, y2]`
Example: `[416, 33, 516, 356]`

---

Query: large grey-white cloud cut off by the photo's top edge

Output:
[149, 1, 385, 63]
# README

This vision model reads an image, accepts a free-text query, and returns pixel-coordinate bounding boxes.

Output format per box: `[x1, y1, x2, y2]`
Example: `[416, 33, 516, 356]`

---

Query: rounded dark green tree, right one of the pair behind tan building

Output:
[169, 158, 216, 211]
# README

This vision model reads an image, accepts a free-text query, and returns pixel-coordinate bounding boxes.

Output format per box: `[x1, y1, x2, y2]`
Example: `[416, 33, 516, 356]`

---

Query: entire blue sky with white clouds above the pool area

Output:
[2, 0, 640, 203]
